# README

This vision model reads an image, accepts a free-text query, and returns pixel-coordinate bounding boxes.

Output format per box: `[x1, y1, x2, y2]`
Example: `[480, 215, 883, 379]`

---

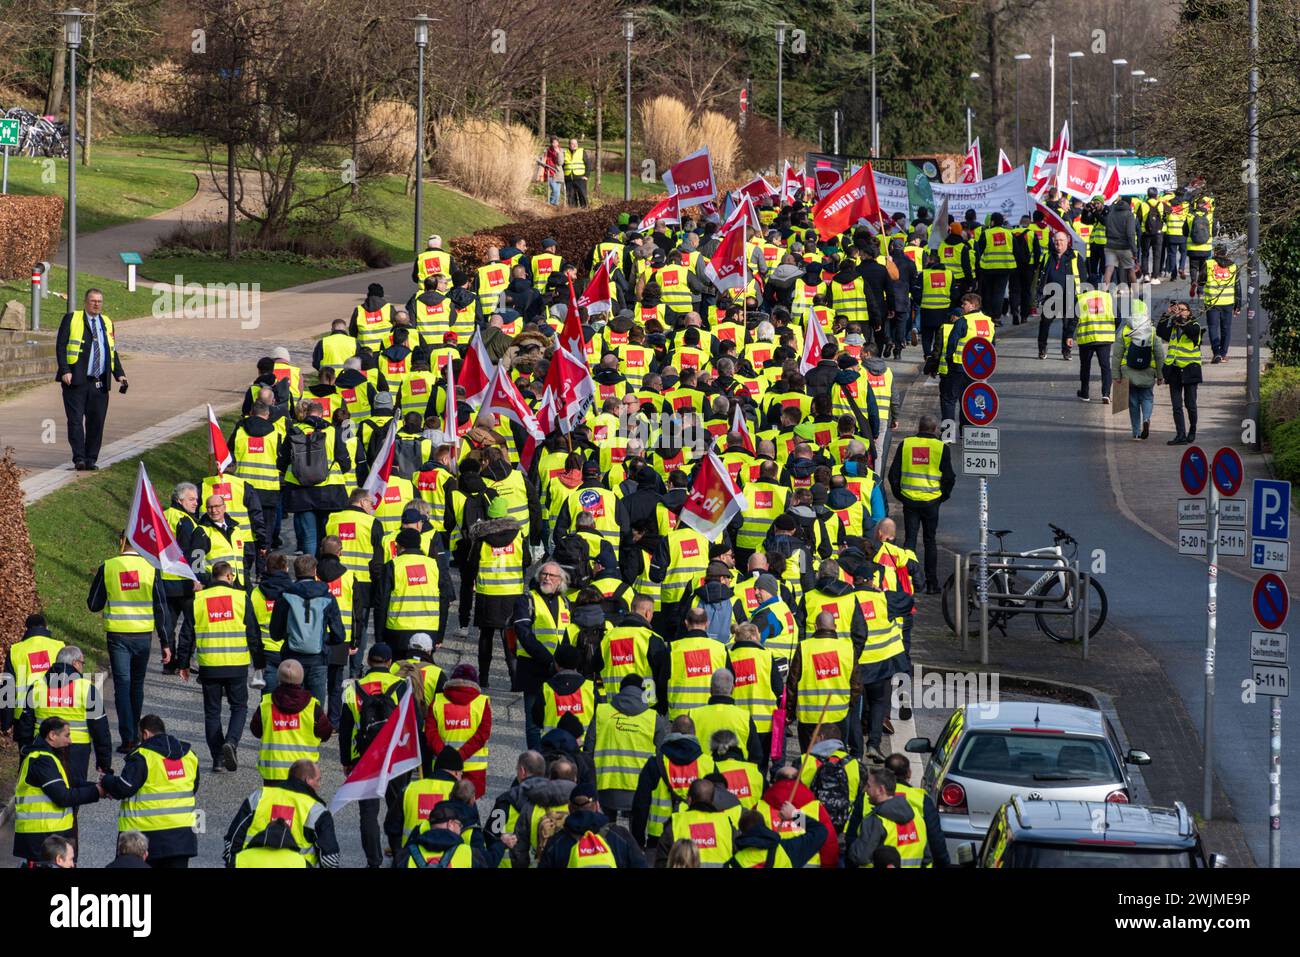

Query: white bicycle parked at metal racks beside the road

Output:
[943, 523, 1109, 641]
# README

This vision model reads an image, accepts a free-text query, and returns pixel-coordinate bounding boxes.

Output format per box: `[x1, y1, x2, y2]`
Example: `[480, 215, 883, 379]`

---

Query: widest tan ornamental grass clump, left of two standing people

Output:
[433, 120, 541, 209]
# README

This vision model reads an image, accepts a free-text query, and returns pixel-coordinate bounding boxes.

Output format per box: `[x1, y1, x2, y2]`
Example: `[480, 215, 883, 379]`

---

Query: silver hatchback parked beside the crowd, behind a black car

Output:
[906, 701, 1151, 857]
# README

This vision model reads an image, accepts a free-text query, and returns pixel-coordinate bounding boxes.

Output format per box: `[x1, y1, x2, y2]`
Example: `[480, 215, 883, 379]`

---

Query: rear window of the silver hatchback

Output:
[954, 731, 1119, 787]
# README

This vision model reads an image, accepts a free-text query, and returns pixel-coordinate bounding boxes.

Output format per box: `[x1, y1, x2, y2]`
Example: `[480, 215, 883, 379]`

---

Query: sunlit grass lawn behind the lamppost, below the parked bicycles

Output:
[9, 140, 198, 235]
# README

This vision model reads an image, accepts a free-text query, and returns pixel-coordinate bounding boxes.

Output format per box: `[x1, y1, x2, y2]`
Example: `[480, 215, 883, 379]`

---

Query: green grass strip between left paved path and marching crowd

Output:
[27, 413, 237, 663]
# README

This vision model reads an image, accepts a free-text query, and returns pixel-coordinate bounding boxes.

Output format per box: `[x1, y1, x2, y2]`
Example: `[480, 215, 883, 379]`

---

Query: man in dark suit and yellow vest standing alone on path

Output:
[55, 289, 126, 472]
